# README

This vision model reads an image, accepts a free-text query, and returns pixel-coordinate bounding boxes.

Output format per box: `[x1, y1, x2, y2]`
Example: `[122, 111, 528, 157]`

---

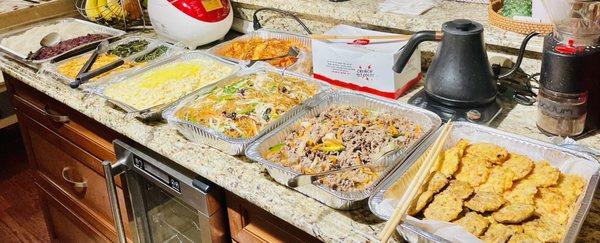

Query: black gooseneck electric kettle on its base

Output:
[394, 19, 531, 124]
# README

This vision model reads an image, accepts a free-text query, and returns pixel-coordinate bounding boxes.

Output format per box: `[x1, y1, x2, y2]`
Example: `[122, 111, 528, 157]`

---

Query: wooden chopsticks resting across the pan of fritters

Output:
[379, 121, 453, 242]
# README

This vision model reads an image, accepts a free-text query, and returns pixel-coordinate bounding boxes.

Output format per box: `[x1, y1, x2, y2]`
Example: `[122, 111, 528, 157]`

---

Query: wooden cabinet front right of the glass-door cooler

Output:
[226, 192, 320, 243]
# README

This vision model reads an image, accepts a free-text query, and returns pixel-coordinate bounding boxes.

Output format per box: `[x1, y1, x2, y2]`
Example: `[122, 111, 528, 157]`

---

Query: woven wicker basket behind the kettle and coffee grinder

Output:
[488, 0, 552, 35]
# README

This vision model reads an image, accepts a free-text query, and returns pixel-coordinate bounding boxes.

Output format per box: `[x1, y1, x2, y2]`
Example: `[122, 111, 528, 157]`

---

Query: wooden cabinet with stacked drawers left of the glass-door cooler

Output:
[5, 76, 130, 242]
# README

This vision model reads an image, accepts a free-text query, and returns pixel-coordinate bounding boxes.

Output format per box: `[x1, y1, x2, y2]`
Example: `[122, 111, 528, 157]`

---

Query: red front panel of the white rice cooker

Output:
[169, 0, 231, 23]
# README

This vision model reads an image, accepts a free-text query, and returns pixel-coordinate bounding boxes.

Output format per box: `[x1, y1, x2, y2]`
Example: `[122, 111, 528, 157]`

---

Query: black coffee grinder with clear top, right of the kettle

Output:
[537, 0, 600, 137]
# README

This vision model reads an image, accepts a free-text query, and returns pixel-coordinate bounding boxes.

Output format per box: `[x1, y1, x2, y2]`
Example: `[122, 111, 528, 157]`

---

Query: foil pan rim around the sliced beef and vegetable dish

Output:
[246, 91, 441, 210]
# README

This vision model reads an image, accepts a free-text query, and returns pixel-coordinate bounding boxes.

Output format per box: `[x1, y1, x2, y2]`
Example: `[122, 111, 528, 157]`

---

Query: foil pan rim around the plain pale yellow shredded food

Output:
[85, 51, 241, 121]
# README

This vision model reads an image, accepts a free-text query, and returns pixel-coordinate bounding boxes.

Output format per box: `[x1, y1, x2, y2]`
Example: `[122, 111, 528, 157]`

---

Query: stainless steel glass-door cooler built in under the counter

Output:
[102, 140, 229, 243]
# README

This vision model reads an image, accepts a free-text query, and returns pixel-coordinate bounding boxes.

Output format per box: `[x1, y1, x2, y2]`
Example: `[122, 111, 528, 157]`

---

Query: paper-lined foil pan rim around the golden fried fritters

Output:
[368, 122, 600, 242]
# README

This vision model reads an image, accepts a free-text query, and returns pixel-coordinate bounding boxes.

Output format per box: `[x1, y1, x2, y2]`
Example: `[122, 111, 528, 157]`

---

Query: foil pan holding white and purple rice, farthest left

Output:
[0, 18, 125, 68]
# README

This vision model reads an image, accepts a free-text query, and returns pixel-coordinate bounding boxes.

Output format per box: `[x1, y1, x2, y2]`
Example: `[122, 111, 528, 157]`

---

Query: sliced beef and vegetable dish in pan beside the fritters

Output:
[263, 105, 423, 191]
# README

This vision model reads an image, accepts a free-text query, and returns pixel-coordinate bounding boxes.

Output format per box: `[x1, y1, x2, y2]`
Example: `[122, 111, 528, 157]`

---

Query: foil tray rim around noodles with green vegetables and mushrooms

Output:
[163, 65, 330, 155]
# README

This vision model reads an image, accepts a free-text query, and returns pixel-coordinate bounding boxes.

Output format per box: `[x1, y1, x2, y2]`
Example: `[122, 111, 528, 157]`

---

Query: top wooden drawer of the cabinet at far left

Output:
[5, 76, 118, 163]
